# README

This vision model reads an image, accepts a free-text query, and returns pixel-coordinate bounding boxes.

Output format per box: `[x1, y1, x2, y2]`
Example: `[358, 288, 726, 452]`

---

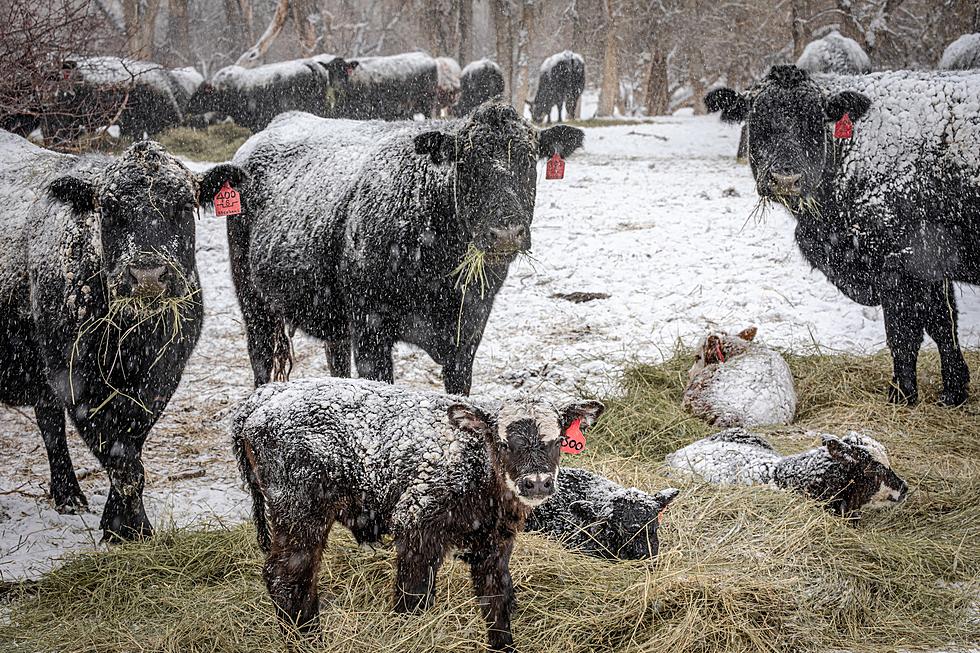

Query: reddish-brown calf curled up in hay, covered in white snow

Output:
[684, 327, 796, 428]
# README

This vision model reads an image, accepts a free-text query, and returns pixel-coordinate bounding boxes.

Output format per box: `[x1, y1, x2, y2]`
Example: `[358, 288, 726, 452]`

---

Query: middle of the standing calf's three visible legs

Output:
[395, 530, 446, 612]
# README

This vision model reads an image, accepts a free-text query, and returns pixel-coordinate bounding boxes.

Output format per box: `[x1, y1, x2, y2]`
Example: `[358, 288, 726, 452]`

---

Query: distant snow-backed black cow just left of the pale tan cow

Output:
[330, 52, 439, 120]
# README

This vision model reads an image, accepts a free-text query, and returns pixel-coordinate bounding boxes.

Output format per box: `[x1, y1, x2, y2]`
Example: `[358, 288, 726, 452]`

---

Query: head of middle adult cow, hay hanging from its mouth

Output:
[415, 102, 585, 260]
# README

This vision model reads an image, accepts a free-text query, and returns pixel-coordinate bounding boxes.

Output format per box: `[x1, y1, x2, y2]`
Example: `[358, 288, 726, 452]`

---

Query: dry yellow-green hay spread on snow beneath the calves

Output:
[0, 352, 980, 653]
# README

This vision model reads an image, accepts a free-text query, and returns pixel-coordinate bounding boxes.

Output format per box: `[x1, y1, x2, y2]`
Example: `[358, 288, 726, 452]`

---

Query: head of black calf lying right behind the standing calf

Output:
[593, 488, 679, 560]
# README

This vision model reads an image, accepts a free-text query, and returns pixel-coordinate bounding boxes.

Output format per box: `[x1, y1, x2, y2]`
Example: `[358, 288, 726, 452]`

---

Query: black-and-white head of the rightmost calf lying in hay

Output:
[819, 432, 908, 514]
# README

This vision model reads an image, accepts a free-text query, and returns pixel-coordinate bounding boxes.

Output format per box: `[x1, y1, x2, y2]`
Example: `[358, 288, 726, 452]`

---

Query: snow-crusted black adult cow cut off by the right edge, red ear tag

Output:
[705, 66, 980, 405]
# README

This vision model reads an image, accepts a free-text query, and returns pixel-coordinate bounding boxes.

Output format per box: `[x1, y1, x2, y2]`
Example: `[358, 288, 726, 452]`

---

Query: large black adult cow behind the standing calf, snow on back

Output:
[228, 104, 583, 394]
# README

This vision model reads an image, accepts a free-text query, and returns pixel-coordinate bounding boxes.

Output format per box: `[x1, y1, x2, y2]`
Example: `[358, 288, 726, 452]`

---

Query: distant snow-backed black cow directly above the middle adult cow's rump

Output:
[187, 55, 358, 132]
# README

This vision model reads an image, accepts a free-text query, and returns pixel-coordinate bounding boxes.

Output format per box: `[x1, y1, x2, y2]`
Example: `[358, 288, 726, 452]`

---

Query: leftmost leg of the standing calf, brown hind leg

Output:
[262, 513, 335, 633]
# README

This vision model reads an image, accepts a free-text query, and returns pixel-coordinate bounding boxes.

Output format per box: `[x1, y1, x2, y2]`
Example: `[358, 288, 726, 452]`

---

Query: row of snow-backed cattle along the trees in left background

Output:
[0, 50, 585, 138]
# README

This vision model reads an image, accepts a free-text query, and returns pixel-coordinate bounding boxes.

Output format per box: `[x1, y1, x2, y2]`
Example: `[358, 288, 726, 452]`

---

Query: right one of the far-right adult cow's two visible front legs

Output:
[924, 279, 970, 406]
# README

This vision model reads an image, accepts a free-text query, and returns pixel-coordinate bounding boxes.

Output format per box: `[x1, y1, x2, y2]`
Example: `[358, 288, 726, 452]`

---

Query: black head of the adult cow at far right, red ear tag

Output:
[704, 66, 871, 204]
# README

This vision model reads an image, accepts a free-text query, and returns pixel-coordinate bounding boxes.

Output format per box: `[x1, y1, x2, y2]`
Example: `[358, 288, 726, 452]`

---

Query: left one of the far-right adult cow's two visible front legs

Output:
[881, 271, 929, 405]
